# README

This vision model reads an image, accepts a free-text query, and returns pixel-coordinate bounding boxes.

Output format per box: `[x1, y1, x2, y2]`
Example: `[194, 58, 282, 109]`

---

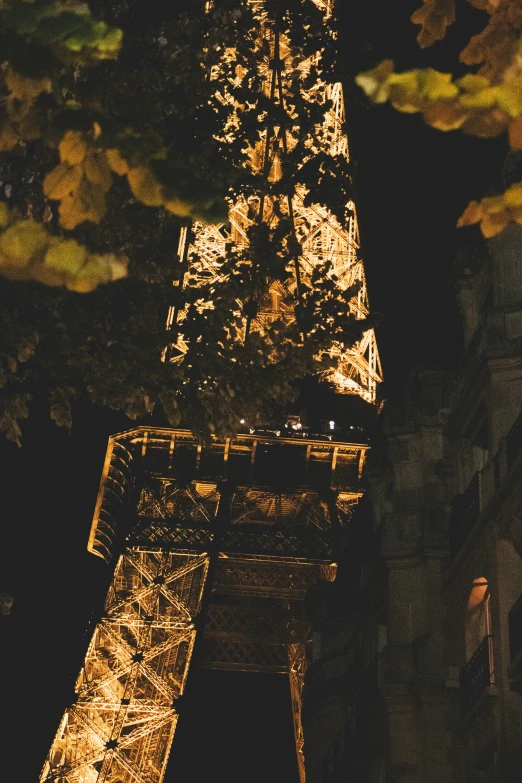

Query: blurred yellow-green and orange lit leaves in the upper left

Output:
[0, 0, 226, 291]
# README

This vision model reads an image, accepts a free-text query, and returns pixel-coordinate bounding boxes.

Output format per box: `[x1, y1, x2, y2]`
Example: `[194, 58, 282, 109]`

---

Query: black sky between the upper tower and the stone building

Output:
[340, 0, 506, 399]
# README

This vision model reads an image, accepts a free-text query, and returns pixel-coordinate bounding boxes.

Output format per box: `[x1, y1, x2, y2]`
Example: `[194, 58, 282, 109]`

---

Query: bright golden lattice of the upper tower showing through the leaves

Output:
[167, 0, 382, 403]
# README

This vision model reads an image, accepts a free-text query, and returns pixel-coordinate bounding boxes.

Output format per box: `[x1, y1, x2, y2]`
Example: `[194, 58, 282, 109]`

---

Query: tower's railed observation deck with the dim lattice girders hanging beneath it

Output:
[89, 427, 369, 673]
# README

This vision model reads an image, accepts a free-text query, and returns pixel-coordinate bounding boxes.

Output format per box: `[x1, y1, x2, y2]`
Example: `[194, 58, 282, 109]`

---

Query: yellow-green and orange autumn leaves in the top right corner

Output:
[356, 0, 522, 237]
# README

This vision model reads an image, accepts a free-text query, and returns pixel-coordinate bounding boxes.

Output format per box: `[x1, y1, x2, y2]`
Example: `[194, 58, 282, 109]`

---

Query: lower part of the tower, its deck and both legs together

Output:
[41, 428, 368, 783]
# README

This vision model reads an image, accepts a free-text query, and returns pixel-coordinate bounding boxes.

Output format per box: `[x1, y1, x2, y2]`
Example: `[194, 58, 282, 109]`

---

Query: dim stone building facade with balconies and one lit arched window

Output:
[304, 225, 522, 783]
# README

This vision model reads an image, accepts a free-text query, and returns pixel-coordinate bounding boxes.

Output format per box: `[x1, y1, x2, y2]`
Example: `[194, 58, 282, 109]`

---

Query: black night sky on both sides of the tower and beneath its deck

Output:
[0, 0, 505, 783]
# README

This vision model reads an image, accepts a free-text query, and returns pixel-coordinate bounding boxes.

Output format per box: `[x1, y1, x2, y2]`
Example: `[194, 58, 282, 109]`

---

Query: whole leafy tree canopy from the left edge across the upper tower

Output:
[0, 0, 368, 441]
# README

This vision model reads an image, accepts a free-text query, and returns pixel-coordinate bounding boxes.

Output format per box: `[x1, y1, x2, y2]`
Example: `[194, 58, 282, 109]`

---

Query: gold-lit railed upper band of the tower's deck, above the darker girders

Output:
[88, 427, 368, 562]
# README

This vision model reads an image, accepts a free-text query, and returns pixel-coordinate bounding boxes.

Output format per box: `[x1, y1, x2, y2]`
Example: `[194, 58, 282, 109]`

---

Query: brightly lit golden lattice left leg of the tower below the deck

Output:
[40, 546, 209, 783]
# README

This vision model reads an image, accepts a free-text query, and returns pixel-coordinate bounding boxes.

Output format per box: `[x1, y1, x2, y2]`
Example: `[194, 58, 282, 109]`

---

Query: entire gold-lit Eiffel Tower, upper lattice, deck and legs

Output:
[40, 0, 382, 783]
